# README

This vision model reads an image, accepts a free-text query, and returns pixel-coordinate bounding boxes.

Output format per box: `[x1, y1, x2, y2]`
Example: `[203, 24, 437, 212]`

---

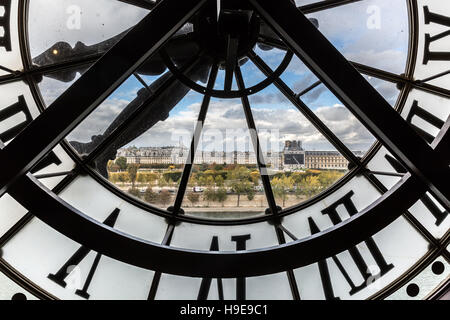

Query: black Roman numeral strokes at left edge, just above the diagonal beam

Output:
[0, 95, 33, 143]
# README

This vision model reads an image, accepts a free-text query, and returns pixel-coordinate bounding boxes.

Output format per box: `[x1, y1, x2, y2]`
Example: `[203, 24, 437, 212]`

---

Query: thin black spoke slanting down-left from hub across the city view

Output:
[173, 63, 219, 215]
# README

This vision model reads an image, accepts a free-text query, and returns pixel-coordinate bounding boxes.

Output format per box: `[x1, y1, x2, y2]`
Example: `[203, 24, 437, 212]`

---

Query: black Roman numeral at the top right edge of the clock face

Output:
[423, 6, 450, 64]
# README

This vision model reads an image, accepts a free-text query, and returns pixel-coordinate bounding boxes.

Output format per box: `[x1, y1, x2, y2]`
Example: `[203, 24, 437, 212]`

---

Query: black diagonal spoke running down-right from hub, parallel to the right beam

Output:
[248, 51, 361, 167]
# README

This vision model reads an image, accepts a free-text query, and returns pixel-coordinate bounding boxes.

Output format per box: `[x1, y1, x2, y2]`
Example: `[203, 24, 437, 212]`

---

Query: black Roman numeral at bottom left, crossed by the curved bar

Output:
[48, 209, 120, 299]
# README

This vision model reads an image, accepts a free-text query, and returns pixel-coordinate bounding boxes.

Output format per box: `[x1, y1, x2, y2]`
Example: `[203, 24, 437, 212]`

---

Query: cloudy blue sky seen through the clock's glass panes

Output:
[29, 0, 408, 155]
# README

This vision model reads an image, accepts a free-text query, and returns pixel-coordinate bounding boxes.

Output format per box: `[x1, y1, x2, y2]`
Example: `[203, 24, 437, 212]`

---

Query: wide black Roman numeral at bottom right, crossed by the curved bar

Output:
[308, 191, 394, 300]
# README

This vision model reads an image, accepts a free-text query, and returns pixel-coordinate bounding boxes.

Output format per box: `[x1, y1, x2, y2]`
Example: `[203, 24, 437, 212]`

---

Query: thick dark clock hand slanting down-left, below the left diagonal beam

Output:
[70, 57, 212, 178]
